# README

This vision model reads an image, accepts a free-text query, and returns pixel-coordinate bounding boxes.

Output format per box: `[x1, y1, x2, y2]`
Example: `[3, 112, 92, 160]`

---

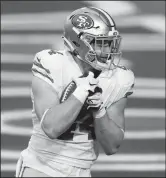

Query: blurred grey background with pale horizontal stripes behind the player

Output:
[1, 1, 165, 177]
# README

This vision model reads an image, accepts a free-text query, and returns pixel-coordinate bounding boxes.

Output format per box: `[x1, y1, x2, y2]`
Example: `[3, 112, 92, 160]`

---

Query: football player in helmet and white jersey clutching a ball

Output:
[16, 7, 134, 177]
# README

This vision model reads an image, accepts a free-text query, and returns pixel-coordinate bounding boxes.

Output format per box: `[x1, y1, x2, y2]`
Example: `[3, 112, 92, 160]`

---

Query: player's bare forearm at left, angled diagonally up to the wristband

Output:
[42, 95, 83, 139]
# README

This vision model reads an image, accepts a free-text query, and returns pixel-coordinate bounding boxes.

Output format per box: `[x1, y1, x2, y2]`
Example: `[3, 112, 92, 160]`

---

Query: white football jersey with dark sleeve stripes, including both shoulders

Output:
[24, 49, 134, 169]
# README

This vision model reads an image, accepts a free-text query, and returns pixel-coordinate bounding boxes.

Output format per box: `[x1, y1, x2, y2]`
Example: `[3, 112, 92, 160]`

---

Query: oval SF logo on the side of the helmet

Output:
[72, 14, 94, 29]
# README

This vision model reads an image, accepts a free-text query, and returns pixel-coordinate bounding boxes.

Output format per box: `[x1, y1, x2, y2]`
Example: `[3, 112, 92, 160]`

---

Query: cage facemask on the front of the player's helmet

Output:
[80, 33, 122, 70]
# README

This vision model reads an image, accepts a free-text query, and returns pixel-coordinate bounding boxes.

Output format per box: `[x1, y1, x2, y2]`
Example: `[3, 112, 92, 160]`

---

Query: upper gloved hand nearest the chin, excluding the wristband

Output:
[73, 72, 99, 92]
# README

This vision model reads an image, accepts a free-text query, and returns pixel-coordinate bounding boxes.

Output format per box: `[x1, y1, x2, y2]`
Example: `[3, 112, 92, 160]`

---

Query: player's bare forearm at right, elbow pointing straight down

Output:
[94, 113, 124, 155]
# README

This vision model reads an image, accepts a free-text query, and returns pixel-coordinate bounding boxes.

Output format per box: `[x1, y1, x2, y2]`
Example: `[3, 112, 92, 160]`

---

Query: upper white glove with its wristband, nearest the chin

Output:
[73, 72, 98, 103]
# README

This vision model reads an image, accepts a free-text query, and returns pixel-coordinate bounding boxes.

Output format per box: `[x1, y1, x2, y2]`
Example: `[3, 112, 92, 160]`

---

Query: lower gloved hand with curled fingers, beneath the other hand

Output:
[86, 92, 103, 111]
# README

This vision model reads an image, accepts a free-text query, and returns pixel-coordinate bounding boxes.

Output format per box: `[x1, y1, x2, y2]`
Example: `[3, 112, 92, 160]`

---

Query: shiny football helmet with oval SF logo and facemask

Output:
[63, 7, 121, 70]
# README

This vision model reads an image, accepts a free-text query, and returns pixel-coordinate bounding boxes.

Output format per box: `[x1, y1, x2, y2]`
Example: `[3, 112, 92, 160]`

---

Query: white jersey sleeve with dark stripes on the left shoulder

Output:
[31, 49, 63, 93]
